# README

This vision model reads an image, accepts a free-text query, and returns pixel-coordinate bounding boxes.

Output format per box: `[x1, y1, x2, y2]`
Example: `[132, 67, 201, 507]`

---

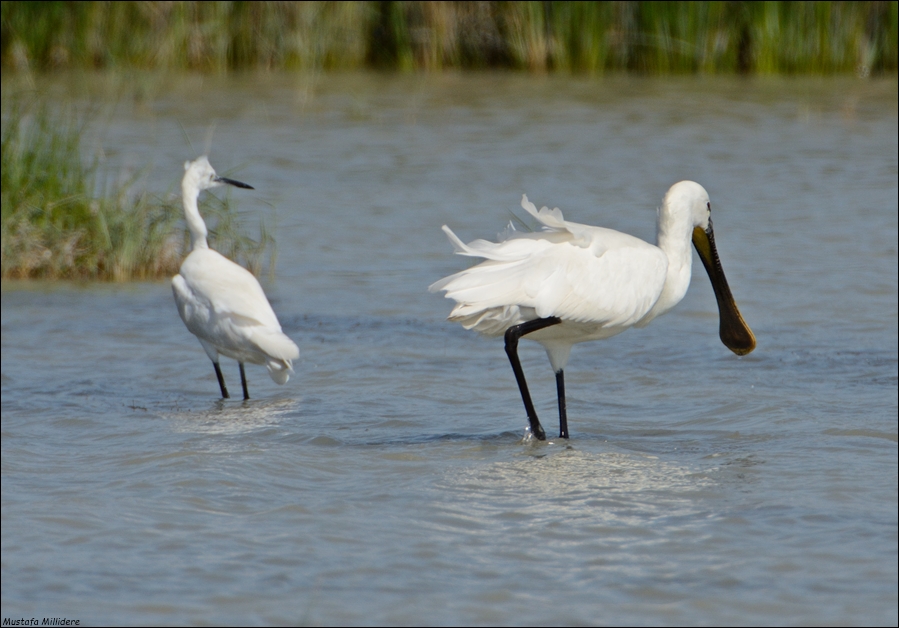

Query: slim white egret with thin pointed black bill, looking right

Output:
[172, 155, 300, 399]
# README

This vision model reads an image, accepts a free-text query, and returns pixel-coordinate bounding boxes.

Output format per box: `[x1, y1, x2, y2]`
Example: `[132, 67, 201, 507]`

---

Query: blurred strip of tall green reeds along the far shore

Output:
[2, 2, 897, 74]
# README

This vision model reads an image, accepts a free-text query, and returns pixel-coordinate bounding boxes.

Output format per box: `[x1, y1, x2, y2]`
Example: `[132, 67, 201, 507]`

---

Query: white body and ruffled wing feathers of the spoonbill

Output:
[430, 196, 668, 335]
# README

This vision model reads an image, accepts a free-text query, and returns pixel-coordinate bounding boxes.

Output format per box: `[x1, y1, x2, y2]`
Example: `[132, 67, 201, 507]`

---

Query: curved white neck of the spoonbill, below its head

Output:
[641, 206, 693, 323]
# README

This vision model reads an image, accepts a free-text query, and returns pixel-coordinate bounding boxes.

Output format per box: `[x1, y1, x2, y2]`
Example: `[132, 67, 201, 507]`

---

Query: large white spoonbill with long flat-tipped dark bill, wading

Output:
[430, 181, 755, 440]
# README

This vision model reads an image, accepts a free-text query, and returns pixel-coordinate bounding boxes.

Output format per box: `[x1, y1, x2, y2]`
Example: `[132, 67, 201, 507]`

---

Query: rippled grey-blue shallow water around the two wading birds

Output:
[2, 74, 899, 625]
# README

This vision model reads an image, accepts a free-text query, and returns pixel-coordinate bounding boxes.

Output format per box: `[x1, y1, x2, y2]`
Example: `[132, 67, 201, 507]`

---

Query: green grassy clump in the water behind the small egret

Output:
[0, 98, 274, 281]
